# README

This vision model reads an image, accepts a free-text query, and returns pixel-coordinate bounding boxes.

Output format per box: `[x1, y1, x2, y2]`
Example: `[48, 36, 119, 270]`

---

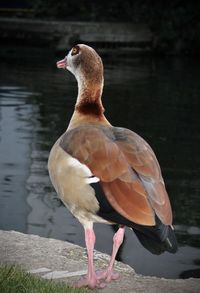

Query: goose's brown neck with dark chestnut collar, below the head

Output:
[68, 80, 110, 129]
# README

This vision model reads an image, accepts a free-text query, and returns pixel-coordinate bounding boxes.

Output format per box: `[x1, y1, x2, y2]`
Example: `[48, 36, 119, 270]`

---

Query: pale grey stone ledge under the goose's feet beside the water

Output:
[0, 231, 200, 293]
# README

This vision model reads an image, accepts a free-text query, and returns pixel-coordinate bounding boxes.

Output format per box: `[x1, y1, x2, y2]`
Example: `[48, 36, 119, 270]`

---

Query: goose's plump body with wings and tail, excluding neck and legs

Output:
[49, 125, 177, 254]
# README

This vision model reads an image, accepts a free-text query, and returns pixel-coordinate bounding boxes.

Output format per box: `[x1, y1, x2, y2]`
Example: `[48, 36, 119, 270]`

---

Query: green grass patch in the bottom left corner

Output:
[0, 265, 90, 293]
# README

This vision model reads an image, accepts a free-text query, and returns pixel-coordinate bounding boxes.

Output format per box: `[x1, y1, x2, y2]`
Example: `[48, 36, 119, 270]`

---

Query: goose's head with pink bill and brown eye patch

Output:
[57, 44, 103, 85]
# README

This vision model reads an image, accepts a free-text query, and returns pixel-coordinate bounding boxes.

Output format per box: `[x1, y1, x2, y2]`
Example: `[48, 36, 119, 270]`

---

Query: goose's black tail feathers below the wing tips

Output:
[133, 218, 178, 254]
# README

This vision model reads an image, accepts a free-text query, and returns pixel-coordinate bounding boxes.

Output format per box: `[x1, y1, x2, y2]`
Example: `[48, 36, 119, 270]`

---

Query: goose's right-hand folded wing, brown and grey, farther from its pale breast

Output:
[114, 127, 172, 225]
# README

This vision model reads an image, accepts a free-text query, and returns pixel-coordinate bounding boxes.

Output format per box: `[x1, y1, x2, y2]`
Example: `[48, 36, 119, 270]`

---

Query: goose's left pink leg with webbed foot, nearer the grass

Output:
[75, 228, 104, 288]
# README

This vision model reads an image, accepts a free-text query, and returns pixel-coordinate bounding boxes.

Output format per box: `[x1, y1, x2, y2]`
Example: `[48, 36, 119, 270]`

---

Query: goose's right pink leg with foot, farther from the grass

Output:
[98, 227, 125, 282]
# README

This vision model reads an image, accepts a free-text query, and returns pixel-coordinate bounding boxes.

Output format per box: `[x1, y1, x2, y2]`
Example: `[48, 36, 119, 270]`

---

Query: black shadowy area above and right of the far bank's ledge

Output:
[0, 0, 200, 55]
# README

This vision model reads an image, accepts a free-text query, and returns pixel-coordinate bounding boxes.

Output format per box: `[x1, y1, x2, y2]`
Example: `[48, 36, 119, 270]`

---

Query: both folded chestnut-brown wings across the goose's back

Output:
[60, 126, 171, 225]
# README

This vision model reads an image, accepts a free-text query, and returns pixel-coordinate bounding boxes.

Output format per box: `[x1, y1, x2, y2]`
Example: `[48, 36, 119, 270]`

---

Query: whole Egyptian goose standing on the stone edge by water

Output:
[48, 44, 177, 288]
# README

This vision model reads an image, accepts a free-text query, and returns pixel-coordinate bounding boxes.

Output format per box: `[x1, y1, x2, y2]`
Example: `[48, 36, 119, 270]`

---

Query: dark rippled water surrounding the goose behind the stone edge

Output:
[0, 49, 200, 278]
